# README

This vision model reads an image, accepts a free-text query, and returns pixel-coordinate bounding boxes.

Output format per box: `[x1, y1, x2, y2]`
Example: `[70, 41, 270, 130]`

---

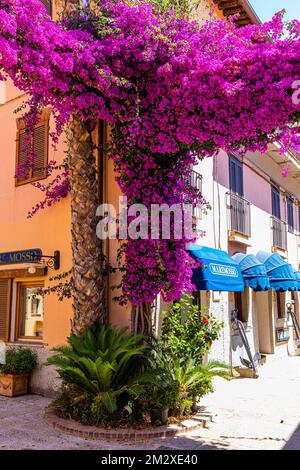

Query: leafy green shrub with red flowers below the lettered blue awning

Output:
[161, 294, 223, 364]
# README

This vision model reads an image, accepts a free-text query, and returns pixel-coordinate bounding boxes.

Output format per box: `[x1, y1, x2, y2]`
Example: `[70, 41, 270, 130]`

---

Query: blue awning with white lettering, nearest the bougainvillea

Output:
[188, 245, 245, 292]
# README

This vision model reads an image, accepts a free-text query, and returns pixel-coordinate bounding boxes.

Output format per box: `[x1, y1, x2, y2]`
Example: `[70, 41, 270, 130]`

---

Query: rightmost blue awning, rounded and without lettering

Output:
[256, 251, 298, 292]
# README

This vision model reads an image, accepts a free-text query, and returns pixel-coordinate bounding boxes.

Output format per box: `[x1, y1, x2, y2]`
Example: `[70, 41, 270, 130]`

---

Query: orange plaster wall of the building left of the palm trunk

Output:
[0, 82, 72, 346]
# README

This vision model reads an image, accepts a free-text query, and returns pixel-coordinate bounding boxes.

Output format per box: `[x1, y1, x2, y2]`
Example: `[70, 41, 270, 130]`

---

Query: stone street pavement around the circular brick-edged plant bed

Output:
[0, 357, 300, 450]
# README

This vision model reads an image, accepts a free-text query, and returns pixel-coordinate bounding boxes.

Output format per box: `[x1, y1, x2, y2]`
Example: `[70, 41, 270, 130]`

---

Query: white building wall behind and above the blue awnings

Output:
[194, 147, 300, 366]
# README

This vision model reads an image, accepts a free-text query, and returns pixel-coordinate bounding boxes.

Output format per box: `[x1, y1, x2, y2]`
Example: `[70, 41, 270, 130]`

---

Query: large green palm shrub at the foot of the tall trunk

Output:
[47, 325, 149, 420]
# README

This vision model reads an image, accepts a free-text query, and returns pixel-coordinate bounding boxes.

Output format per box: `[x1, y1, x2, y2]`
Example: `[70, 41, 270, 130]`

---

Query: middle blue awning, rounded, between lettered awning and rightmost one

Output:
[233, 253, 271, 292]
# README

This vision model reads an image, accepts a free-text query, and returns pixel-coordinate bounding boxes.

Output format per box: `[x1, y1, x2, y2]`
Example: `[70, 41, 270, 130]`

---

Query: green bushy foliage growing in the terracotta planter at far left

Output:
[0, 348, 37, 375]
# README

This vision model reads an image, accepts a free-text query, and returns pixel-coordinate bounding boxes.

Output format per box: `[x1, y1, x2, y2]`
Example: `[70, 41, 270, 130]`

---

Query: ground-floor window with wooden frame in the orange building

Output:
[16, 282, 44, 340]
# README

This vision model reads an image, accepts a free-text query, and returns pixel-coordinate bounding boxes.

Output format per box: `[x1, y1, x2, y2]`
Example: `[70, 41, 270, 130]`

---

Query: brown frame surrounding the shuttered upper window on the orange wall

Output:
[15, 110, 50, 187]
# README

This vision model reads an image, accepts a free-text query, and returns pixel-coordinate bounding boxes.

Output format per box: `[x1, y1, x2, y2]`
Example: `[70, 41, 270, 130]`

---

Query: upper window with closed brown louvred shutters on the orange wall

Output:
[16, 115, 49, 186]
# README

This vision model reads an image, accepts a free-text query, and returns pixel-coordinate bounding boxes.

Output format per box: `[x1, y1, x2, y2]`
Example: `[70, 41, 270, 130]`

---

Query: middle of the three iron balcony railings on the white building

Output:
[227, 192, 251, 237]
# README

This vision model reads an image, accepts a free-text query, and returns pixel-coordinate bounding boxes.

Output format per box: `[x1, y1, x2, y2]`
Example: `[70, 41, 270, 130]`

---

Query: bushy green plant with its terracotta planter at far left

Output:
[0, 348, 37, 397]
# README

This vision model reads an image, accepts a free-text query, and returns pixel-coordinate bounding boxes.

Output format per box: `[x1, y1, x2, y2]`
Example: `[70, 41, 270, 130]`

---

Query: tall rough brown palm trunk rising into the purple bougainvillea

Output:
[67, 115, 106, 336]
